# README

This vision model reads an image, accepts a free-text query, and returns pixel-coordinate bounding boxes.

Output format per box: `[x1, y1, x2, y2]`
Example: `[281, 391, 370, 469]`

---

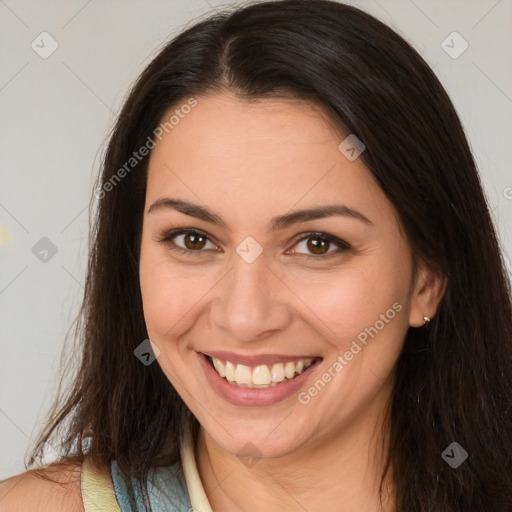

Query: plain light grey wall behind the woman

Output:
[0, 0, 512, 479]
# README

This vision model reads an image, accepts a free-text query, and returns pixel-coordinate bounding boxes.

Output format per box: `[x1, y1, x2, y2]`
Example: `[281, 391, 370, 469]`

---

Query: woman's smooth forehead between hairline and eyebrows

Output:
[147, 94, 390, 228]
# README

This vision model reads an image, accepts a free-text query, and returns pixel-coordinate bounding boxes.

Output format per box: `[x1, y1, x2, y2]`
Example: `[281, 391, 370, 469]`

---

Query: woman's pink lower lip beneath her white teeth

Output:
[198, 353, 321, 407]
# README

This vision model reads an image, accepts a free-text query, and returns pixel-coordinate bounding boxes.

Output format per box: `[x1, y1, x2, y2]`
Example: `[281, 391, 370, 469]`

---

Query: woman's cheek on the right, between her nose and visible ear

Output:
[294, 248, 411, 378]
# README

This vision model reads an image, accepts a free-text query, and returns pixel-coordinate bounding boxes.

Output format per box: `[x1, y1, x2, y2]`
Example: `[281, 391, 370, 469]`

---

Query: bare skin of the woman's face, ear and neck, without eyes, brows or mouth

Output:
[140, 92, 446, 512]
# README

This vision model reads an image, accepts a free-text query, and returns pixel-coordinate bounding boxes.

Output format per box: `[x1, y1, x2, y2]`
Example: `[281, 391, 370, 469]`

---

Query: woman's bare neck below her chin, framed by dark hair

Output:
[196, 390, 394, 512]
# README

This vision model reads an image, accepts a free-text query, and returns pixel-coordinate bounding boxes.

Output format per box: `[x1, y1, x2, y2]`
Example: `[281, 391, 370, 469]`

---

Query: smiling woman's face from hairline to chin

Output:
[140, 94, 440, 457]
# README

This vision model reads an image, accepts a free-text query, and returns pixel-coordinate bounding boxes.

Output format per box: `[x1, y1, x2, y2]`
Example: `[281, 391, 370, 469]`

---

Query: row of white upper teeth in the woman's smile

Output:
[212, 357, 313, 388]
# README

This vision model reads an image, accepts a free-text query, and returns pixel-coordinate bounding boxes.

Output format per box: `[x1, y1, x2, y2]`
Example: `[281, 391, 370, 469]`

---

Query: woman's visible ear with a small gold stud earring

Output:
[409, 262, 448, 327]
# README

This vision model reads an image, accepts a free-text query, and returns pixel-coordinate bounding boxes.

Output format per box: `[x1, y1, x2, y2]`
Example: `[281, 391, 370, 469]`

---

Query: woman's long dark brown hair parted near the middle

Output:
[28, 0, 512, 512]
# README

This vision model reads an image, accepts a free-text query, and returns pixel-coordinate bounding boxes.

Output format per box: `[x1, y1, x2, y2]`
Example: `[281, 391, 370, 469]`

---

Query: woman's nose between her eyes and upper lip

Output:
[210, 250, 292, 342]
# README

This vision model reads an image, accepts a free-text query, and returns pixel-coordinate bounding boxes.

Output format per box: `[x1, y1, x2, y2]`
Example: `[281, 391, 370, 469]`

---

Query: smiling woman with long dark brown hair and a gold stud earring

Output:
[2, 0, 512, 512]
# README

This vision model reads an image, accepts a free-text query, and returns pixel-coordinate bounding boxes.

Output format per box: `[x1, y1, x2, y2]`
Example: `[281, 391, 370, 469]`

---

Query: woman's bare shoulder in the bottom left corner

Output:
[0, 462, 84, 512]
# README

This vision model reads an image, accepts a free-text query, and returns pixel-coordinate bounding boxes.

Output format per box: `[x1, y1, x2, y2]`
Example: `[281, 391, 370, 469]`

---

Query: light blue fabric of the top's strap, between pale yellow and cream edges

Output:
[111, 461, 192, 512]
